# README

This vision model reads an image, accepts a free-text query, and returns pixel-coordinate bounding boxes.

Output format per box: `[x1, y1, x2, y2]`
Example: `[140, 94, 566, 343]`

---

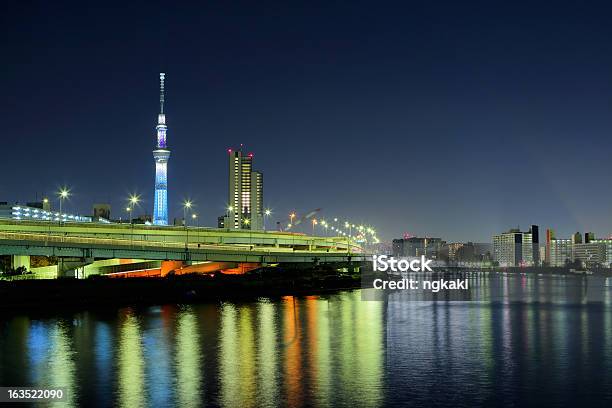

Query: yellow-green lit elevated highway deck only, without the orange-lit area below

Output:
[0, 220, 364, 263]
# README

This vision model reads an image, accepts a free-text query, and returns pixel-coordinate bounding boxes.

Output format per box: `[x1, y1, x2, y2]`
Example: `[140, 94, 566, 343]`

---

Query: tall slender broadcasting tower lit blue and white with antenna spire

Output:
[153, 72, 170, 225]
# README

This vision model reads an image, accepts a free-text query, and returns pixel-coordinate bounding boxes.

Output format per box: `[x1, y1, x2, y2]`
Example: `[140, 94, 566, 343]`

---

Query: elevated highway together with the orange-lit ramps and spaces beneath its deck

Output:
[0, 220, 366, 277]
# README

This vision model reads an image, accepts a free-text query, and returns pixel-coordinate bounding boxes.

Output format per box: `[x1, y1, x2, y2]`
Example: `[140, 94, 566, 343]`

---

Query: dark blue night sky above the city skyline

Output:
[0, 1, 612, 241]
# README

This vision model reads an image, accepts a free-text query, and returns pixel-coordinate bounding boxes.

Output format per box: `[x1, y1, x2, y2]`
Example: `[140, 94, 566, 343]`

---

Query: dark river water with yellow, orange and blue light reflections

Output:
[0, 276, 612, 408]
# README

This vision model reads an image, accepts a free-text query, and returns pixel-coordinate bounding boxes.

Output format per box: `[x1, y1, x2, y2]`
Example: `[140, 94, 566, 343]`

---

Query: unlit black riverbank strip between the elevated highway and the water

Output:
[0, 271, 360, 311]
